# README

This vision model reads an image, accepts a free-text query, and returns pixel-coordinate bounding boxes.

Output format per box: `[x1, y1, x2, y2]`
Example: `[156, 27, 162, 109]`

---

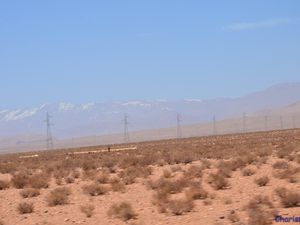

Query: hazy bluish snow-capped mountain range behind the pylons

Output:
[0, 83, 300, 139]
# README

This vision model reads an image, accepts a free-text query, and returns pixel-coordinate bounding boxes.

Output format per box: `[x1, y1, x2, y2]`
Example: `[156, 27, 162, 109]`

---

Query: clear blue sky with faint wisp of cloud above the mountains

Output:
[0, 0, 300, 109]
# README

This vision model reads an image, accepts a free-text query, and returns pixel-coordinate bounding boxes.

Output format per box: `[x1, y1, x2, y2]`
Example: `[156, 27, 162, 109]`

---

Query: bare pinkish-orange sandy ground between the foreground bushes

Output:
[0, 157, 300, 225]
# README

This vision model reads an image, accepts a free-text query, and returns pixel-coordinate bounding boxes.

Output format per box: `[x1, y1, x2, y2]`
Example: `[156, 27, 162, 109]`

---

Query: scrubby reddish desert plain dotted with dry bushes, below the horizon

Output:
[0, 130, 300, 225]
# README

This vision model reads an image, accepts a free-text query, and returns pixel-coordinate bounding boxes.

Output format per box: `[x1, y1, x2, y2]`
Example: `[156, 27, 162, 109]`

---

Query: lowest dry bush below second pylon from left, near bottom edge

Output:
[107, 202, 137, 221]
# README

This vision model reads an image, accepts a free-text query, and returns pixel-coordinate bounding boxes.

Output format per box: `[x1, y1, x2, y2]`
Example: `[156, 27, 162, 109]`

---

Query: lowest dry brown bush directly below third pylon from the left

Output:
[168, 199, 195, 215]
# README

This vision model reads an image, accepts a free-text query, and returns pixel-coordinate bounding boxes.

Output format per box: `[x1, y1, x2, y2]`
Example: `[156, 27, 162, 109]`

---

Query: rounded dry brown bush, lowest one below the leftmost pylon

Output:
[46, 187, 71, 206]
